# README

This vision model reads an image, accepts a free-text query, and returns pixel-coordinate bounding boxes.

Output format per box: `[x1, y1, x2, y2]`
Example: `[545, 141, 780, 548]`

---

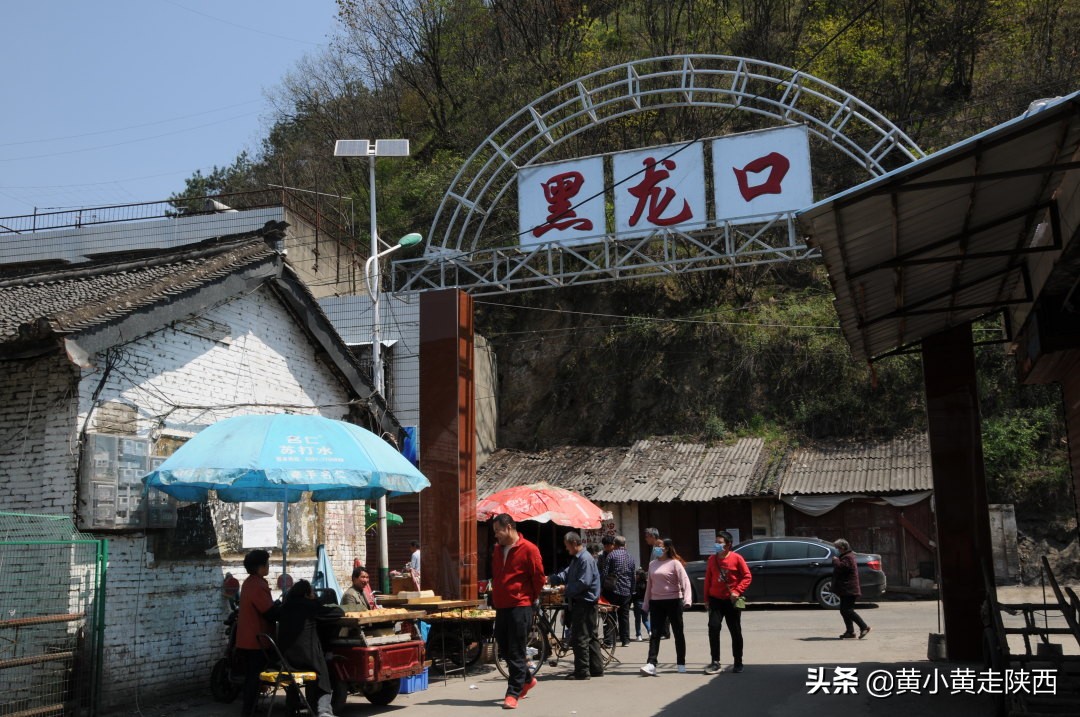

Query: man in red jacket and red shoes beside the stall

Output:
[491, 513, 545, 709]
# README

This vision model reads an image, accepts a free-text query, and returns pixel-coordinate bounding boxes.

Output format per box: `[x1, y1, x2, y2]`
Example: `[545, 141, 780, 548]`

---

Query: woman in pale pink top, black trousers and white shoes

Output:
[642, 538, 692, 677]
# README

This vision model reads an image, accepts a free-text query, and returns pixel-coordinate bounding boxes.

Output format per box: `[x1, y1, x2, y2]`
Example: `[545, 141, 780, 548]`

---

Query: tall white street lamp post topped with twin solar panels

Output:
[334, 139, 421, 593]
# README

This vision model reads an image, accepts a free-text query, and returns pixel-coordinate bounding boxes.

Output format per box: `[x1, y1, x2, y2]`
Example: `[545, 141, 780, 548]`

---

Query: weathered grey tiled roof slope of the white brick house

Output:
[0, 228, 276, 343]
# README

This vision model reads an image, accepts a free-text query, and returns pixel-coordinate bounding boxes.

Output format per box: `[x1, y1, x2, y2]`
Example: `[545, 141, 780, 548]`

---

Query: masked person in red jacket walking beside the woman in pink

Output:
[705, 530, 752, 675]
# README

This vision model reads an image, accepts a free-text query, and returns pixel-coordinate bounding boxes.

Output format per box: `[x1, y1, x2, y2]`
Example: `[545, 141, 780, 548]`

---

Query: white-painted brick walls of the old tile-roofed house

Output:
[0, 289, 364, 707]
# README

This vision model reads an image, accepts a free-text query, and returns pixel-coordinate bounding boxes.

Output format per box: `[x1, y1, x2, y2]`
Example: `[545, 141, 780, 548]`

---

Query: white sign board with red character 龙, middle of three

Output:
[612, 141, 708, 238]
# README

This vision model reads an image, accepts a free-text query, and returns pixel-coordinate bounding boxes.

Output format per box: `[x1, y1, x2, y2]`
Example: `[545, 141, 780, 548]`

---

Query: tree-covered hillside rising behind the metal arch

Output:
[164, 0, 1080, 492]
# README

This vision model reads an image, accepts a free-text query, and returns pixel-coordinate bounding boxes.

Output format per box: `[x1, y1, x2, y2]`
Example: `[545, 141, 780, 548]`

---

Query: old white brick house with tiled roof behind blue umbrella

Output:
[0, 222, 396, 712]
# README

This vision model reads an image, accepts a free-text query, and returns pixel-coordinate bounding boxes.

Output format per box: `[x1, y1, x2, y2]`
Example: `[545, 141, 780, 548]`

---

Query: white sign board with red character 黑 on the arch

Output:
[517, 157, 607, 246]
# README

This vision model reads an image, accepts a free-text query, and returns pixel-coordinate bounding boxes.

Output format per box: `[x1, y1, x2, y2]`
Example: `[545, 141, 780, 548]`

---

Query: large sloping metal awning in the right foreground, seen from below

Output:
[798, 93, 1080, 360]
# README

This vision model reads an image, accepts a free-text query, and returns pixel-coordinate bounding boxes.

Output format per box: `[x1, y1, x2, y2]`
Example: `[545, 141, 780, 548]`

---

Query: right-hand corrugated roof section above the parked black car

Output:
[780, 434, 933, 495]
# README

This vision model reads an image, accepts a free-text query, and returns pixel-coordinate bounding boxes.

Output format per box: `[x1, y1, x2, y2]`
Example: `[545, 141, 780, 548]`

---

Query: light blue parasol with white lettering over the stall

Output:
[143, 414, 431, 570]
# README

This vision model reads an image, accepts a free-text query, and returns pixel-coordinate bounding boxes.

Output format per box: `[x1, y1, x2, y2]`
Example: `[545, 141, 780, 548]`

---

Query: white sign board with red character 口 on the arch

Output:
[713, 125, 813, 224]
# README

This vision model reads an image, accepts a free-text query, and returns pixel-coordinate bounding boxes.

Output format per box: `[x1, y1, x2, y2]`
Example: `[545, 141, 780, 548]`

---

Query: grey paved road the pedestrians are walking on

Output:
[108, 595, 1075, 717]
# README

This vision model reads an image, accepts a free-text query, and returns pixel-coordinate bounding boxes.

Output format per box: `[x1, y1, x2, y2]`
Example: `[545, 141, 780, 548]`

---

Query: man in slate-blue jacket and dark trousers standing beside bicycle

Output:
[548, 530, 604, 679]
